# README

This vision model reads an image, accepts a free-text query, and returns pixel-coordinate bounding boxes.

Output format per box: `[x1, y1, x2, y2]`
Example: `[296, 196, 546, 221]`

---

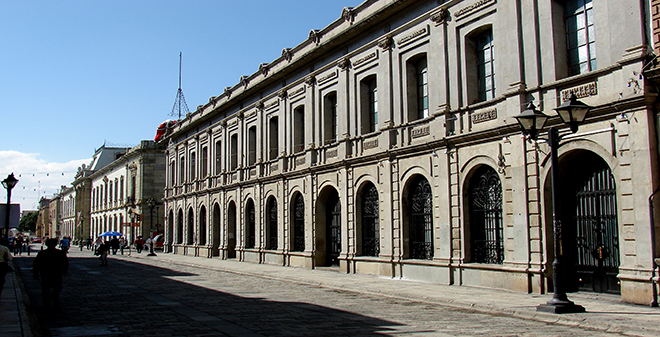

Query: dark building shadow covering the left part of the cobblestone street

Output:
[15, 254, 400, 337]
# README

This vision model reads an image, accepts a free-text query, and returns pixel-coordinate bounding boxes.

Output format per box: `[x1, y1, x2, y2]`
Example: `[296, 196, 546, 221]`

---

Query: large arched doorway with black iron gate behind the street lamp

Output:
[559, 151, 621, 294]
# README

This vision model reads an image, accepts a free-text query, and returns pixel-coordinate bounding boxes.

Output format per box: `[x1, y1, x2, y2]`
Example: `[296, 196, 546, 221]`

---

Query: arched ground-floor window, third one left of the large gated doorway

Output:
[362, 183, 380, 256]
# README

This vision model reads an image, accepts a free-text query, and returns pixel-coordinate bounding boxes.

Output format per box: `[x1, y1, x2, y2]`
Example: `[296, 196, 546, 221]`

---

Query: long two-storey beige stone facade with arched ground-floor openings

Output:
[163, 0, 659, 304]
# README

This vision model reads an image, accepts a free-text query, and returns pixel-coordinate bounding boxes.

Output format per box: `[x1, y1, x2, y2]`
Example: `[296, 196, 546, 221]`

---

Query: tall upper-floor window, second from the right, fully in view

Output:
[476, 29, 495, 101]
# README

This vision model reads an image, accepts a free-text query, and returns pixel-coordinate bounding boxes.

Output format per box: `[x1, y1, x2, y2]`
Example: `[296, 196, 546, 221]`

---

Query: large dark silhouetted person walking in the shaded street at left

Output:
[32, 239, 69, 307]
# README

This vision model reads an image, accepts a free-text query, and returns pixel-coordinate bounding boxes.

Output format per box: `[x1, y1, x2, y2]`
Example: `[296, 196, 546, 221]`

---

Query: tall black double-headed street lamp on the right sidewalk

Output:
[516, 94, 591, 314]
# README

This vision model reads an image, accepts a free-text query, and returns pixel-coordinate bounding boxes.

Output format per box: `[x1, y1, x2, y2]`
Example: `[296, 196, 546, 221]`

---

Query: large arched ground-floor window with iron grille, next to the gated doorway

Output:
[468, 165, 504, 264]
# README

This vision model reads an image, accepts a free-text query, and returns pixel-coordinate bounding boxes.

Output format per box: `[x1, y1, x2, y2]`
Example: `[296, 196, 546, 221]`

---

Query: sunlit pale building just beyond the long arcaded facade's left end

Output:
[86, 141, 165, 243]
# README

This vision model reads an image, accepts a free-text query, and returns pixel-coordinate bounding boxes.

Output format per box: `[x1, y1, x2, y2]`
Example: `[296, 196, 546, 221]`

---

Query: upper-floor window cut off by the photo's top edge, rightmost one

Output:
[564, 0, 596, 75]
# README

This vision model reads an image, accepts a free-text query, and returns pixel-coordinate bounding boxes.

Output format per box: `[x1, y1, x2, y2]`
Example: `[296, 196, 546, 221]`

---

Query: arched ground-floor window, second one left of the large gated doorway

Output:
[408, 176, 433, 260]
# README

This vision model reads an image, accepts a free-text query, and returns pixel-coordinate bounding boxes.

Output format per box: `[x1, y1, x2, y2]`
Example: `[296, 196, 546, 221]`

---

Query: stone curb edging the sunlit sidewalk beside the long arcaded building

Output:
[116, 256, 660, 337]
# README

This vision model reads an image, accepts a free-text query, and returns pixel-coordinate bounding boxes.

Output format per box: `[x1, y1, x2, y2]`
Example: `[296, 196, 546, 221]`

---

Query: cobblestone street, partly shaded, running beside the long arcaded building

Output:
[16, 245, 652, 337]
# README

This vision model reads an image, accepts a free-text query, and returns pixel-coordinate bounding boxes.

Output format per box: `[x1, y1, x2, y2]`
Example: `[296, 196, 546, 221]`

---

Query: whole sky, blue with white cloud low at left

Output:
[0, 0, 362, 210]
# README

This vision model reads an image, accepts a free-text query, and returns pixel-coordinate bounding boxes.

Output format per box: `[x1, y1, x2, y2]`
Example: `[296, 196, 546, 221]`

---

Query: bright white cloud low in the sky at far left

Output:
[0, 151, 91, 211]
